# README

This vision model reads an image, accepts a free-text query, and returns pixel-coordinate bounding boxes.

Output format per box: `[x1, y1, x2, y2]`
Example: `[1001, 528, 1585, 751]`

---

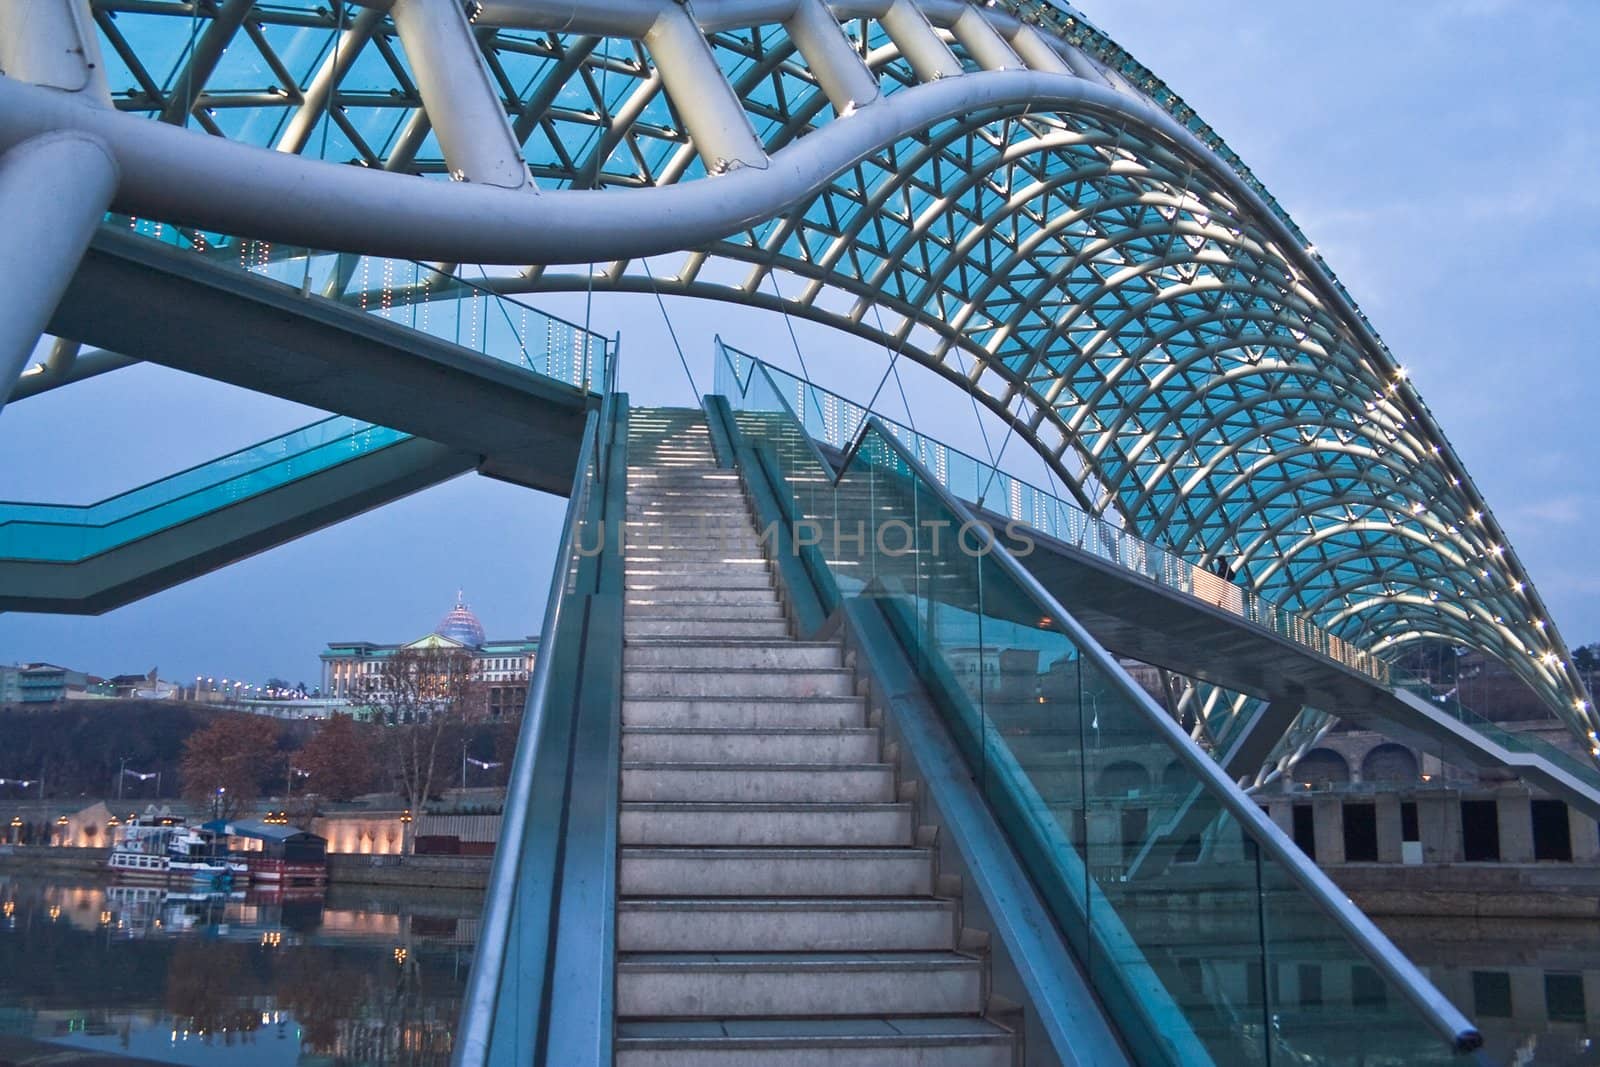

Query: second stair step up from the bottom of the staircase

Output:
[616, 952, 982, 1019]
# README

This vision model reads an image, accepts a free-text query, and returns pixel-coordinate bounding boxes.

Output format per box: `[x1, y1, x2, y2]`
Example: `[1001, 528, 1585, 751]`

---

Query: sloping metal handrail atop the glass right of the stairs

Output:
[867, 414, 1483, 1051]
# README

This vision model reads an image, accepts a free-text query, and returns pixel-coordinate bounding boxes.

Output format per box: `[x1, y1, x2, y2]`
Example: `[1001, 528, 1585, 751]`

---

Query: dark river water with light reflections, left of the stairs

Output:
[0, 875, 480, 1067]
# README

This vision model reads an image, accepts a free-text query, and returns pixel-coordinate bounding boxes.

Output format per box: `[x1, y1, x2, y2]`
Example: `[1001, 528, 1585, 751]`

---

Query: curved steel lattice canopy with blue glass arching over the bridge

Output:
[0, 0, 1600, 751]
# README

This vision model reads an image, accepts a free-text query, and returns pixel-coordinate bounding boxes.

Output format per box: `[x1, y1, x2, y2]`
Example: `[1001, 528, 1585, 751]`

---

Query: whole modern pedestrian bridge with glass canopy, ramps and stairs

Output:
[0, 0, 1600, 1067]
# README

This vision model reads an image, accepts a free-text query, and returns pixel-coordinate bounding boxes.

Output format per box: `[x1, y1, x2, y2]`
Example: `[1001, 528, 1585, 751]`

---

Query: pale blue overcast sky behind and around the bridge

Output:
[0, 0, 1600, 683]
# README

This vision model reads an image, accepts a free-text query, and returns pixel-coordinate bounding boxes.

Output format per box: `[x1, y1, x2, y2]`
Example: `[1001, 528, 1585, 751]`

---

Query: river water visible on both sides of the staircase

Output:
[0, 872, 1600, 1067]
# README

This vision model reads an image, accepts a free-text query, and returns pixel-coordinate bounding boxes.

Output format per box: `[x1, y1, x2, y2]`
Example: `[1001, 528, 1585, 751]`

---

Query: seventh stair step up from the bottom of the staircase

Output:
[622, 726, 882, 765]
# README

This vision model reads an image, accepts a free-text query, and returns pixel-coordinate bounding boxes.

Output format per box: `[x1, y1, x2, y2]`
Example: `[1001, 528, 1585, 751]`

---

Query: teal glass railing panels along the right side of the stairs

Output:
[713, 373, 1477, 1067]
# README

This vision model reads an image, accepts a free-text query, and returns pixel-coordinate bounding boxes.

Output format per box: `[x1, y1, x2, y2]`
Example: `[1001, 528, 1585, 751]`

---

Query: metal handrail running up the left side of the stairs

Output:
[453, 411, 600, 1065]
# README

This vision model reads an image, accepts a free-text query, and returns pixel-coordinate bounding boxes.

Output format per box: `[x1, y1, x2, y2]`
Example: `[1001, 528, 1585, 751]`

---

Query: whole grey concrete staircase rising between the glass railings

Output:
[616, 410, 1016, 1067]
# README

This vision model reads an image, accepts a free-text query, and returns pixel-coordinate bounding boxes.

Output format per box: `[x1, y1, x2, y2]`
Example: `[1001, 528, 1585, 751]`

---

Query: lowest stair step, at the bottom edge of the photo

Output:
[616, 1016, 1014, 1067]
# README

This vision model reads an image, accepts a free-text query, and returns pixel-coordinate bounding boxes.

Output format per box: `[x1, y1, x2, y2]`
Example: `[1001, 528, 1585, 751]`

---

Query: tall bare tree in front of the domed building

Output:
[365, 645, 488, 851]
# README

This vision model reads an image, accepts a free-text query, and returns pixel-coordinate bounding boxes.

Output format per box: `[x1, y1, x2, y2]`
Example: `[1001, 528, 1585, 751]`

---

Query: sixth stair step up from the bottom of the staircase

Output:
[622, 761, 894, 803]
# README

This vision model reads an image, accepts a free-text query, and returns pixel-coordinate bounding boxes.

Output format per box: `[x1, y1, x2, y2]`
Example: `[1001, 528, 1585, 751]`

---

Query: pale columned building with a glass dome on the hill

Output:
[320, 590, 539, 718]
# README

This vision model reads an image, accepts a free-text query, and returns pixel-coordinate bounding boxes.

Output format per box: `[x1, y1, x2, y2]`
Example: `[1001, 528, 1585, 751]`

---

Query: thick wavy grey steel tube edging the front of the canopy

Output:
[0, 67, 1177, 264]
